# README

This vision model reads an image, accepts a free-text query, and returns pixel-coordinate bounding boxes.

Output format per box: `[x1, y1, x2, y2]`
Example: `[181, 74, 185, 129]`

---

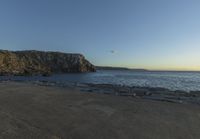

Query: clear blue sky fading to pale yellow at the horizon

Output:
[0, 0, 200, 70]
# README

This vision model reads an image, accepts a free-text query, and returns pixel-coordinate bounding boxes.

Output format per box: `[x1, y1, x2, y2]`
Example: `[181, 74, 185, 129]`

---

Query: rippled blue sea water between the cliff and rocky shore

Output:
[0, 70, 200, 91]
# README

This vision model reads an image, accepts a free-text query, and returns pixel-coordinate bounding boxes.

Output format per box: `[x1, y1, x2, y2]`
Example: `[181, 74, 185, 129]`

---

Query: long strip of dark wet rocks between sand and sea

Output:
[19, 81, 200, 105]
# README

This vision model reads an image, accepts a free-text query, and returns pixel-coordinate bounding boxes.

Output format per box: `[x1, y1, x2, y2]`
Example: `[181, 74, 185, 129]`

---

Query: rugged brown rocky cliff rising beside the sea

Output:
[0, 51, 95, 75]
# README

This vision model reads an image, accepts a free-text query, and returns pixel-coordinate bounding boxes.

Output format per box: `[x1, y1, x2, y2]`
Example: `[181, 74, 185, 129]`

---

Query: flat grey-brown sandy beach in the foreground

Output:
[0, 82, 200, 139]
